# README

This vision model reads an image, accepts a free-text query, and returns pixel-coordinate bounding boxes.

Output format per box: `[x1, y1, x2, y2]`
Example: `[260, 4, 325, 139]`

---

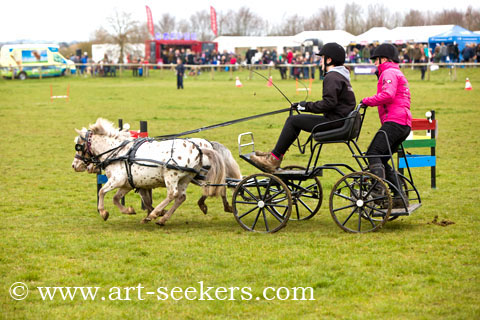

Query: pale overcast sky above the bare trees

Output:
[0, 0, 480, 42]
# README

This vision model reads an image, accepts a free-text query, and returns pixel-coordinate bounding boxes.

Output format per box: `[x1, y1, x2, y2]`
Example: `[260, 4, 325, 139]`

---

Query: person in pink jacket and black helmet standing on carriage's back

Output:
[361, 43, 412, 206]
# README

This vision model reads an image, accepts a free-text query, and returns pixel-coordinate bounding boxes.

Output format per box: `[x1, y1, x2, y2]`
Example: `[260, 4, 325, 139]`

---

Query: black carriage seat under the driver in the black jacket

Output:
[312, 105, 362, 143]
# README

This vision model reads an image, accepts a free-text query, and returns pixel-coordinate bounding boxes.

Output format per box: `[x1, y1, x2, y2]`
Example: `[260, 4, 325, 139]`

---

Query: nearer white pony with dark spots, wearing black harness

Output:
[72, 118, 235, 225]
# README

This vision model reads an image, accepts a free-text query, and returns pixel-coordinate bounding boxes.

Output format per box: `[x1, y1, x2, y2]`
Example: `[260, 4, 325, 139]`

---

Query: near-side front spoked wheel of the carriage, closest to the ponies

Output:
[232, 173, 293, 233]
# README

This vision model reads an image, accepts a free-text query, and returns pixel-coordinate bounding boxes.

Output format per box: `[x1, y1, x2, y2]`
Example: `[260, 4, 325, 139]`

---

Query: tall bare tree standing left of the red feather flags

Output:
[107, 10, 138, 61]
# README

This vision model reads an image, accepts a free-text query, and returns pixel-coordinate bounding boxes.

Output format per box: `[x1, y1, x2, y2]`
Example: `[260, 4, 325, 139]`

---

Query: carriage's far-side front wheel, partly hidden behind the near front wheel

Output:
[283, 166, 323, 220]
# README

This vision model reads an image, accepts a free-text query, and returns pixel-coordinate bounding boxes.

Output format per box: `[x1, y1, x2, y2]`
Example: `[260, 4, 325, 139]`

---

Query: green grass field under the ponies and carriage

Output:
[0, 68, 480, 319]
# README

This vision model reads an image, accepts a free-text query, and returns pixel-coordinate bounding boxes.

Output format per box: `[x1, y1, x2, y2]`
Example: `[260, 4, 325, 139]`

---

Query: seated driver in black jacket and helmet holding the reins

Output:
[250, 42, 356, 172]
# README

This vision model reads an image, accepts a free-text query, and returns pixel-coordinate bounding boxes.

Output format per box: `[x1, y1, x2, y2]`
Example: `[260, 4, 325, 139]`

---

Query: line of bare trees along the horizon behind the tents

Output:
[91, 2, 480, 43]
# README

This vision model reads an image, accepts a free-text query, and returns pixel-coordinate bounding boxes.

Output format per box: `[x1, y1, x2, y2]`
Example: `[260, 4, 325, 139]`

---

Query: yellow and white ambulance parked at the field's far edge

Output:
[0, 44, 76, 80]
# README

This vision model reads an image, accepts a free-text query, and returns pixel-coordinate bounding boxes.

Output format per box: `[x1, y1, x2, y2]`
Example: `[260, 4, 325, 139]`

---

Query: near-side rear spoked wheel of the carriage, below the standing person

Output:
[330, 172, 392, 233]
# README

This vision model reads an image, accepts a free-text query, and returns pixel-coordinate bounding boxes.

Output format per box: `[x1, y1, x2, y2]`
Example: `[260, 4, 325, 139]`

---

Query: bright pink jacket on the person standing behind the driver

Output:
[362, 62, 412, 127]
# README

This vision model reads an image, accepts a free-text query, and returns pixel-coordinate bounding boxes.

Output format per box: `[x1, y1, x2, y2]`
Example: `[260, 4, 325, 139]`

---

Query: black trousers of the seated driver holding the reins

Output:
[272, 114, 343, 158]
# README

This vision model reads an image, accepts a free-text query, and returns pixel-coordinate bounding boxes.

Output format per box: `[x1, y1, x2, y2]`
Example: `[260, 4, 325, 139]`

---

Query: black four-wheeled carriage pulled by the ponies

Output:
[231, 104, 421, 233]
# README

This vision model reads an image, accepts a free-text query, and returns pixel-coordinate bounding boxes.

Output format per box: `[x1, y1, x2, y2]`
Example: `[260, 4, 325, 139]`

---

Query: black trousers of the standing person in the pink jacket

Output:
[367, 122, 411, 171]
